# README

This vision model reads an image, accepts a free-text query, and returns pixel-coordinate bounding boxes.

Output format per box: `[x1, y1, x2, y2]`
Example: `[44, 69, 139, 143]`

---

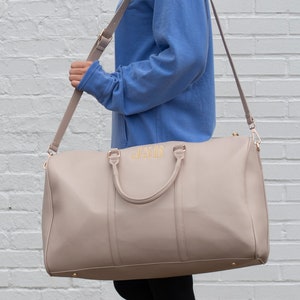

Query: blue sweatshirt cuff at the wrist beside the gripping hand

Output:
[77, 61, 114, 103]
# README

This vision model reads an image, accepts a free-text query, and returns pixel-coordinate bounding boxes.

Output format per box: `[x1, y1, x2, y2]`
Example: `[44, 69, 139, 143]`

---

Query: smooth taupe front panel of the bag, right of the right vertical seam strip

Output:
[180, 137, 255, 262]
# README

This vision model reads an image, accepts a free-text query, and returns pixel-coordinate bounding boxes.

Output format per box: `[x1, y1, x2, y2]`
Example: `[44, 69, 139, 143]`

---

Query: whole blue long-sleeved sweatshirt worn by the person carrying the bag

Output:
[78, 0, 215, 148]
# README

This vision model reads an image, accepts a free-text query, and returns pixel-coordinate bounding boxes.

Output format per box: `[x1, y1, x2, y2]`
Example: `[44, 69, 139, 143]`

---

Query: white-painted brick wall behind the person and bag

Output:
[0, 0, 300, 300]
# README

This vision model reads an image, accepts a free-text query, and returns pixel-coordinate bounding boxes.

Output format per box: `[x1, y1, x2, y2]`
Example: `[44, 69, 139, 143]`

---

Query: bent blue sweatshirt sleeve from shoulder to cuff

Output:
[78, 0, 210, 115]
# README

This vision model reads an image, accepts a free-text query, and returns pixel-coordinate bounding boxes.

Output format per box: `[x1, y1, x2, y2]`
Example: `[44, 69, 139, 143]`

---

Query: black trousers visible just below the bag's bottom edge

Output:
[114, 276, 195, 300]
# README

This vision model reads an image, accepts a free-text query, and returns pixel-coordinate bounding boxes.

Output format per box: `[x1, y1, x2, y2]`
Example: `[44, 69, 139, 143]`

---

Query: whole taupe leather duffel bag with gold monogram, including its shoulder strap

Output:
[42, 0, 269, 280]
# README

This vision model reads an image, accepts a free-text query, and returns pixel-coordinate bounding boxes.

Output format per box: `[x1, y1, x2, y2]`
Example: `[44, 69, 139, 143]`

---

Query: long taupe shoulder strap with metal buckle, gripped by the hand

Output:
[48, 0, 261, 155]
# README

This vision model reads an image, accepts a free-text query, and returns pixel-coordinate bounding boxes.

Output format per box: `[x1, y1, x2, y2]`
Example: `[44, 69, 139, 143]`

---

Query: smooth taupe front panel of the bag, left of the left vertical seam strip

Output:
[47, 151, 113, 272]
